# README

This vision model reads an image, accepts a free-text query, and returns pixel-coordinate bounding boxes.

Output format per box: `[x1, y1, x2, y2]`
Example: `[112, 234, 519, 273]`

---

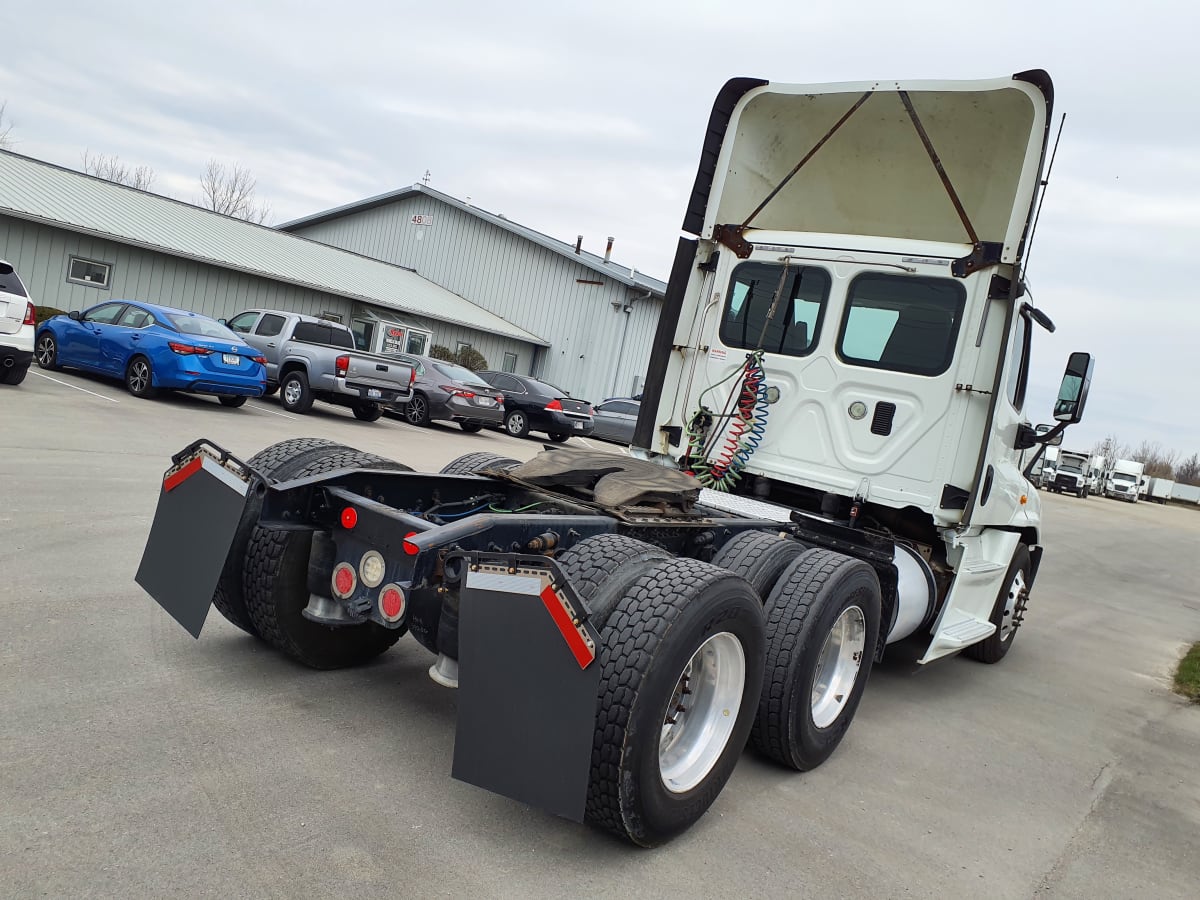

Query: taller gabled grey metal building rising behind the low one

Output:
[280, 185, 666, 402]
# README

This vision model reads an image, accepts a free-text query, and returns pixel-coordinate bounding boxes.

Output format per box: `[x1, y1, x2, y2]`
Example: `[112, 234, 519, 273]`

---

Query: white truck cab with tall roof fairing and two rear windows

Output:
[635, 71, 1092, 661]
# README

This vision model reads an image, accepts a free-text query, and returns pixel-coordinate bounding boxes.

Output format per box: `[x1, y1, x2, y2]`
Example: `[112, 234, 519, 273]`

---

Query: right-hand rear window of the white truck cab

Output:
[838, 272, 966, 376]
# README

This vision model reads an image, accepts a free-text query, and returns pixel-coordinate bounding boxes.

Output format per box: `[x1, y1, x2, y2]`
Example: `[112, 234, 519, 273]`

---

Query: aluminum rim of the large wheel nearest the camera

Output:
[659, 631, 746, 793]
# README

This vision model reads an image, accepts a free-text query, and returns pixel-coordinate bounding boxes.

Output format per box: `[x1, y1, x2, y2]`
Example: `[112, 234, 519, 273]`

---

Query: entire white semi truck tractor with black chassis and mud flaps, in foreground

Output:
[137, 71, 1092, 846]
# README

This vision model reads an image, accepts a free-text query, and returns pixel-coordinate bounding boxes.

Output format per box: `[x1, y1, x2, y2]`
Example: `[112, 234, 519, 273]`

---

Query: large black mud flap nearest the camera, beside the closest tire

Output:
[452, 554, 600, 822]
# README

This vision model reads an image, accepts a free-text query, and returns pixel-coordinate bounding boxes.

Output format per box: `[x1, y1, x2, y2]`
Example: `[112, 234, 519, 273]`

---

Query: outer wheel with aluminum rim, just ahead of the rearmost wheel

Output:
[750, 550, 880, 772]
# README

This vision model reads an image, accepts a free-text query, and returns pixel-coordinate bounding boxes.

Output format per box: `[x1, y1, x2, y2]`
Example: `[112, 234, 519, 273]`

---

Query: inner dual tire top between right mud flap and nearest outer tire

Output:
[558, 534, 671, 629]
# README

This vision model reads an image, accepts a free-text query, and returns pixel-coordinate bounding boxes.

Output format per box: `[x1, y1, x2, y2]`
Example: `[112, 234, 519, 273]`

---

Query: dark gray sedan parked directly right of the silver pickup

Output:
[391, 354, 504, 432]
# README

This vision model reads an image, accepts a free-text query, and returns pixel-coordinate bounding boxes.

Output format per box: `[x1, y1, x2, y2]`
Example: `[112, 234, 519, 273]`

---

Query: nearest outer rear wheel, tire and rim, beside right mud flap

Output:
[584, 559, 763, 847]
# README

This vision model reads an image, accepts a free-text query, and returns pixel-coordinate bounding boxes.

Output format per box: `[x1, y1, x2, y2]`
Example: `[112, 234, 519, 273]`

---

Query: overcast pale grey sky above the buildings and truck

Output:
[0, 0, 1200, 456]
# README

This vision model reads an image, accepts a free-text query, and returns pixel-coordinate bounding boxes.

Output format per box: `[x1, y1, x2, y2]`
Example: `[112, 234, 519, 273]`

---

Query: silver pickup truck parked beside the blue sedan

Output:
[226, 310, 415, 422]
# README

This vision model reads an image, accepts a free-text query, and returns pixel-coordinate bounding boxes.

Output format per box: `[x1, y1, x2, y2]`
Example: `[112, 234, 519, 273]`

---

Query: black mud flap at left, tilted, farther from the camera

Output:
[134, 451, 248, 637]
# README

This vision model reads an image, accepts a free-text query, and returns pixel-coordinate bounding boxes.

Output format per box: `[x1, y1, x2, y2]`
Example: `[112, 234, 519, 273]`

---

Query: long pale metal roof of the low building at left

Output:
[0, 150, 548, 347]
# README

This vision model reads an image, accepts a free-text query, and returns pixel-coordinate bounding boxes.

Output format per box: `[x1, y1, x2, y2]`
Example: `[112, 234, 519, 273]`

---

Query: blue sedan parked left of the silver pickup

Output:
[34, 300, 266, 407]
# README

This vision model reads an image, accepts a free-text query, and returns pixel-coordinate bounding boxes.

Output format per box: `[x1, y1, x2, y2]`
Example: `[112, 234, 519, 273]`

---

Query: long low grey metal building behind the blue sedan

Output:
[0, 151, 547, 364]
